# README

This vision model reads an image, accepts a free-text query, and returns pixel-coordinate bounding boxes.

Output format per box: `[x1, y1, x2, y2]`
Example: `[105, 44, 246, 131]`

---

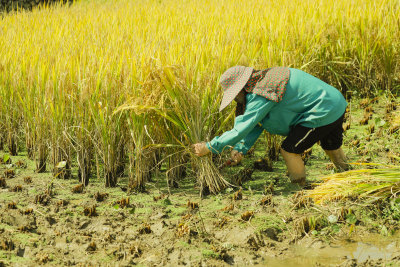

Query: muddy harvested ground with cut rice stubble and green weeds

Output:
[0, 97, 400, 266]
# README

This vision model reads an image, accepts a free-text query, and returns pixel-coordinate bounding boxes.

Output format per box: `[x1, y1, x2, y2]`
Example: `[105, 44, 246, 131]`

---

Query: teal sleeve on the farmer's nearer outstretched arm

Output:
[207, 94, 276, 154]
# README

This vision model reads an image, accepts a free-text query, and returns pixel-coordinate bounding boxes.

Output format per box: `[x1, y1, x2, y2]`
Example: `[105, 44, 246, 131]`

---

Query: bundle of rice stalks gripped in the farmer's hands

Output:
[154, 66, 229, 195]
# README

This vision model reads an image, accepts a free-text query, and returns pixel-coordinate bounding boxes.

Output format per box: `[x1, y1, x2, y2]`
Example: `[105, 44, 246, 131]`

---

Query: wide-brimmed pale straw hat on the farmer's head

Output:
[219, 66, 253, 111]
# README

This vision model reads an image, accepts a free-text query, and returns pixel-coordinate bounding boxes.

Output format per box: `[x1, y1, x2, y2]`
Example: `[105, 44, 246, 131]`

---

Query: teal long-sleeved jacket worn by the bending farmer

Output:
[206, 68, 347, 154]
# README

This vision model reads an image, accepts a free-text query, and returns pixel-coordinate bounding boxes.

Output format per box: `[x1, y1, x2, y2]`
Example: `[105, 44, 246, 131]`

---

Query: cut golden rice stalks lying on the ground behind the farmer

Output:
[308, 163, 400, 203]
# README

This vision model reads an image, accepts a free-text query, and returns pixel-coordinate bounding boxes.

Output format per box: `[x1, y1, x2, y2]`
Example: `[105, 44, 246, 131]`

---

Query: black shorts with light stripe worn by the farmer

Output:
[282, 114, 344, 154]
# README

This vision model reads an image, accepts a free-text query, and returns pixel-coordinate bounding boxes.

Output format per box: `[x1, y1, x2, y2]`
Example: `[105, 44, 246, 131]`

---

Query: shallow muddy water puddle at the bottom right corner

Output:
[263, 234, 400, 267]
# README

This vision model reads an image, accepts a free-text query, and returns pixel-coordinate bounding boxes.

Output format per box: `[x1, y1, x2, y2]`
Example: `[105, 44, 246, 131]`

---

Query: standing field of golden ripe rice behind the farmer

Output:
[0, 0, 400, 193]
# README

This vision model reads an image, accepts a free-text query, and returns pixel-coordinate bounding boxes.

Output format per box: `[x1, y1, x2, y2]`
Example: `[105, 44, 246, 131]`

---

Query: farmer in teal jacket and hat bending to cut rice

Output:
[193, 66, 348, 186]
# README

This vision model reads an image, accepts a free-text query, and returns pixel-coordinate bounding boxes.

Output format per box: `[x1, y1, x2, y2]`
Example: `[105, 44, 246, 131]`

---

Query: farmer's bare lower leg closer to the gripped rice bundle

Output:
[281, 148, 306, 186]
